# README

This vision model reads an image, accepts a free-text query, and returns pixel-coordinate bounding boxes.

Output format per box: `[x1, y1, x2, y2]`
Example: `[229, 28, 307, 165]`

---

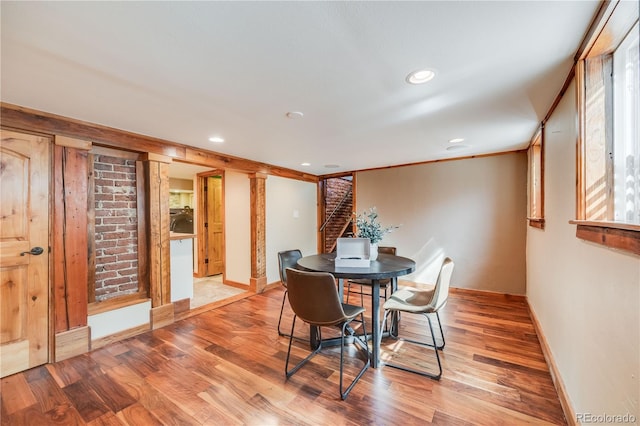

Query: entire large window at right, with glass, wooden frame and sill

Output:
[575, 2, 640, 254]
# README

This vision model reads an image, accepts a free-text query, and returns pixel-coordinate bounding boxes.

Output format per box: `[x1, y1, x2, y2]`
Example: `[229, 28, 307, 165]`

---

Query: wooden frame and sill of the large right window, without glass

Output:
[569, 1, 640, 255]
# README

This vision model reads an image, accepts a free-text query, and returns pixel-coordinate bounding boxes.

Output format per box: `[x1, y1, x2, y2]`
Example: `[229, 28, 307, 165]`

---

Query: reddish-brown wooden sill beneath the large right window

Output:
[569, 220, 640, 255]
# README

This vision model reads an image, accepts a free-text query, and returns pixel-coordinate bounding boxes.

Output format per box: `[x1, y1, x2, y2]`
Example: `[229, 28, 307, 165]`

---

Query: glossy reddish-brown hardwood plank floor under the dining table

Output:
[0, 288, 565, 425]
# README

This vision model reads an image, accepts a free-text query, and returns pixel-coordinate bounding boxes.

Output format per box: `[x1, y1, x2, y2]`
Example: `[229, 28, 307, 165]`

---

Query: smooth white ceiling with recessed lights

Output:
[0, 1, 598, 175]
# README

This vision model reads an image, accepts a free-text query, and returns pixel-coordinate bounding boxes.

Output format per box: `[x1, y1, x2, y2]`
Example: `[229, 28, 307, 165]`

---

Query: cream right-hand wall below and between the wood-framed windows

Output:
[527, 83, 640, 424]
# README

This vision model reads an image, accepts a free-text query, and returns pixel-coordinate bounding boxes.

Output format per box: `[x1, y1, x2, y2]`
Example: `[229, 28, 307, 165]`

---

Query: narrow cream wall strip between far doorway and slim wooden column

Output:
[224, 171, 251, 285]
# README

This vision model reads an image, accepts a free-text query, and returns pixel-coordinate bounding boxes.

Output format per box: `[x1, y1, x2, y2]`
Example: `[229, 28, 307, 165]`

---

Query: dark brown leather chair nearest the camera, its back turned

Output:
[284, 268, 371, 400]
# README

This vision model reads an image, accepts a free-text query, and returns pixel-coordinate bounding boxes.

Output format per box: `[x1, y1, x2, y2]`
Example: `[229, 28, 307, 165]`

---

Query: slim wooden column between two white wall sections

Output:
[249, 173, 267, 293]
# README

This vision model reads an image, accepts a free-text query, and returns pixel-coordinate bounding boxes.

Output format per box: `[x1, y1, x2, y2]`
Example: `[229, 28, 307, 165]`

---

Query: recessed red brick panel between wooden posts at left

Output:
[93, 155, 138, 301]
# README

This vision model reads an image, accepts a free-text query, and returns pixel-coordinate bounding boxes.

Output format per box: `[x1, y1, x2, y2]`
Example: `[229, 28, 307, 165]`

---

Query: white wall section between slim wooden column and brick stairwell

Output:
[266, 176, 318, 283]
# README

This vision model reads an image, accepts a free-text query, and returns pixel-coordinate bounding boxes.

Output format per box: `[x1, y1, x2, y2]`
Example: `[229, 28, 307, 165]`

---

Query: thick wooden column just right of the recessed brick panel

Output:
[142, 154, 173, 329]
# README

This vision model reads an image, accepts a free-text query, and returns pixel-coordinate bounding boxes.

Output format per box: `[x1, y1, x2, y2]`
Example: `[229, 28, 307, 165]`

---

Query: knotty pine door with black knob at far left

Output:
[0, 130, 50, 377]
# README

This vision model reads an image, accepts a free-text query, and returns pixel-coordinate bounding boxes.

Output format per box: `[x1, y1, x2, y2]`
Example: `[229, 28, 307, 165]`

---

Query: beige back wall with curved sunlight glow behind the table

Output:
[356, 153, 527, 294]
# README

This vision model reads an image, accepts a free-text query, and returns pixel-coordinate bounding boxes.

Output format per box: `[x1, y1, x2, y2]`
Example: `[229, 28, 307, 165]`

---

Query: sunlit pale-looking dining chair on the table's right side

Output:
[380, 257, 454, 380]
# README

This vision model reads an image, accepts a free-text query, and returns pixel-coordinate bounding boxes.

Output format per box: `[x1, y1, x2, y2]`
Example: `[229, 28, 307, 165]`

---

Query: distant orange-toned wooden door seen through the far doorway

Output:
[205, 176, 224, 275]
